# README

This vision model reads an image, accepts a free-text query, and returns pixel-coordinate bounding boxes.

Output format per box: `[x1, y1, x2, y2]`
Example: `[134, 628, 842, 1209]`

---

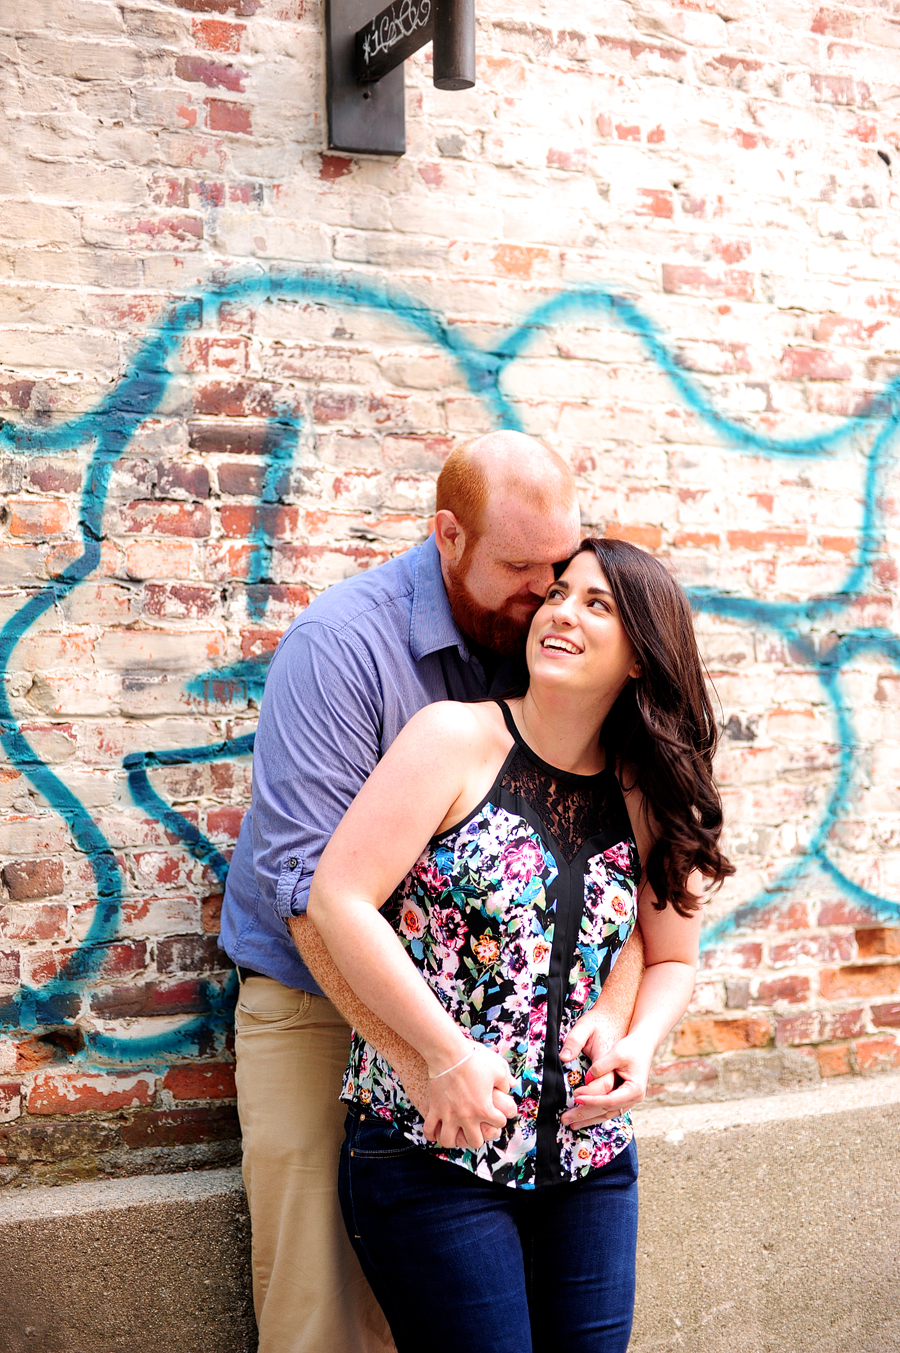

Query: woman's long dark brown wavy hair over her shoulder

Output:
[571, 537, 735, 916]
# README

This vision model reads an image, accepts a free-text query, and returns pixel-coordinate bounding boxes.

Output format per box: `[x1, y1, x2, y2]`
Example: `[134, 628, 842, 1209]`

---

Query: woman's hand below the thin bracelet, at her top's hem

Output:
[425, 1042, 516, 1151]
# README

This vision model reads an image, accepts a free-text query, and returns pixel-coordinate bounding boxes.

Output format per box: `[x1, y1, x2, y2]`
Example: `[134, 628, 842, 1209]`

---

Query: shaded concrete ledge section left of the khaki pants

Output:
[0, 1169, 254, 1353]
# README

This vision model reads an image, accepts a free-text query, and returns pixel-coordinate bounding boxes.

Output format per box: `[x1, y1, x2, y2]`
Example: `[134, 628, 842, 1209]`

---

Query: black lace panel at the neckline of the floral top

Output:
[501, 747, 618, 862]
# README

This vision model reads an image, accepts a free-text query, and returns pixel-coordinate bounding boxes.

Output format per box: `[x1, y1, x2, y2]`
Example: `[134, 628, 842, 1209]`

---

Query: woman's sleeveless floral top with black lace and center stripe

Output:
[341, 702, 640, 1188]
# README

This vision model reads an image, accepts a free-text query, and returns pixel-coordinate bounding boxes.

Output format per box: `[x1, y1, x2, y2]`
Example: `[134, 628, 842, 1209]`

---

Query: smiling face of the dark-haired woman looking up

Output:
[526, 549, 640, 700]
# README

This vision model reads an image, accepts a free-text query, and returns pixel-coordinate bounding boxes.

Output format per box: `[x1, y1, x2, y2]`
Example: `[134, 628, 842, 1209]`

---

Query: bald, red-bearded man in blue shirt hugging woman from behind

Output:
[222, 432, 642, 1353]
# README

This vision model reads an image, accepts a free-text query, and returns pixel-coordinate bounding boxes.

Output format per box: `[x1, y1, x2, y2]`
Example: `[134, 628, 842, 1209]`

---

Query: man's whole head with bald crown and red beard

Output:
[434, 432, 579, 653]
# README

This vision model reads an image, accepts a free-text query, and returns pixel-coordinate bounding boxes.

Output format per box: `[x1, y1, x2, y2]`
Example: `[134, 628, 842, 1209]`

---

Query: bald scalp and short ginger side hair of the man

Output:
[436, 432, 578, 547]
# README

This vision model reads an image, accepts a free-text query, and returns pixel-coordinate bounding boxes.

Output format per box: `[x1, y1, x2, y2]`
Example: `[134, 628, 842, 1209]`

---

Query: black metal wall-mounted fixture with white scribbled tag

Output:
[325, 0, 475, 156]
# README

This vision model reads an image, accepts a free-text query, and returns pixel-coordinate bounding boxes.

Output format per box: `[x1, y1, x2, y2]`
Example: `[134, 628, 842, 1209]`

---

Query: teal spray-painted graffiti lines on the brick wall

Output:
[0, 269, 900, 1057]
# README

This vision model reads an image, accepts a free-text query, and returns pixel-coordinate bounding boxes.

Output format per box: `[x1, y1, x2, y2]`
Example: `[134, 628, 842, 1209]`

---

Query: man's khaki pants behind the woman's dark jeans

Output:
[235, 977, 394, 1353]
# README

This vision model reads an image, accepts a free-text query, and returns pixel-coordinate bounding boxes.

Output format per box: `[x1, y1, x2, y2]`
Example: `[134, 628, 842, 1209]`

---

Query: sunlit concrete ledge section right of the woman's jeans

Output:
[631, 1074, 900, 1353]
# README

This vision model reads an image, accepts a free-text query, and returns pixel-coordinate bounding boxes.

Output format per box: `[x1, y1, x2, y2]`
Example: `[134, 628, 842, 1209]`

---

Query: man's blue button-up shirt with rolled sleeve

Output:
[221, 536, 498, 993]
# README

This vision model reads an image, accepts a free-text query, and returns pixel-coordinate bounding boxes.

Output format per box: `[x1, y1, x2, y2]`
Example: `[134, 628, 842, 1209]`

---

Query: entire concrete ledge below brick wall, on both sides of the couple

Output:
[0, 1074, 900, 1353]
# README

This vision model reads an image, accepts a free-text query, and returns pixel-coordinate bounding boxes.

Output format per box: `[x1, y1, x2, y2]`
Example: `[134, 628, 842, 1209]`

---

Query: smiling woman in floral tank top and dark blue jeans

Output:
[310, 540, 732, 1353]
